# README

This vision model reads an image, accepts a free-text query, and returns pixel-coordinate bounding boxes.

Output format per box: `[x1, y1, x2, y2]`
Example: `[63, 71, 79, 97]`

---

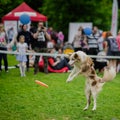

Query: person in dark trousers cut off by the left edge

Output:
[0, 24, 8, 72]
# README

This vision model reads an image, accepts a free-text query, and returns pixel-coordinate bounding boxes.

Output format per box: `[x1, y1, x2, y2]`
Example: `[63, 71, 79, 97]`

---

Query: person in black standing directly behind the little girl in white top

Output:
[17, 24, 32, 71]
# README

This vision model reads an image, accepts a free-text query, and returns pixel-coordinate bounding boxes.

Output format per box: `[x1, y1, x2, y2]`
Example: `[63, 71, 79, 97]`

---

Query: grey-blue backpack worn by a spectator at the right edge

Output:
[109, 38, 119, 52]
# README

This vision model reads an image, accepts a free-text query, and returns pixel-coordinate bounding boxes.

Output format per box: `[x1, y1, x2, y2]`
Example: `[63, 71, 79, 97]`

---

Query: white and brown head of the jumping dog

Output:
[69, 51, 88, 65]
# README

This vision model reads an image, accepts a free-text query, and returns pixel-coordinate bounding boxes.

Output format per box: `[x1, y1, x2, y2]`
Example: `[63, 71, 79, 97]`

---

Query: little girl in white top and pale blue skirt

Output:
[17, 35, 28, 77]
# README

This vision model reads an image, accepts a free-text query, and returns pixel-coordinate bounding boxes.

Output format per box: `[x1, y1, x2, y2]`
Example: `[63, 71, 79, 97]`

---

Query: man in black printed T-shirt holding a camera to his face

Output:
[32, 21, 50, 74]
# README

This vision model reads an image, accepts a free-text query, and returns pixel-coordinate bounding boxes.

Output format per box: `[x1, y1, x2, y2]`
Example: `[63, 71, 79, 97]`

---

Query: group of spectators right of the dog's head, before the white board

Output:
[72, 26, 120, 72]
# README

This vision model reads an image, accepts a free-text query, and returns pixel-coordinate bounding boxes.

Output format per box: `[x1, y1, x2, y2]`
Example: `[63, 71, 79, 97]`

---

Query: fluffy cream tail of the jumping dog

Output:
[101, 67, 116, 82]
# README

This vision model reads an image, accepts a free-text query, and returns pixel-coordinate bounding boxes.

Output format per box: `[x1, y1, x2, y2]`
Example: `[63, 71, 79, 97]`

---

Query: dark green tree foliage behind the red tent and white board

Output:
[0, 0, 120, 40]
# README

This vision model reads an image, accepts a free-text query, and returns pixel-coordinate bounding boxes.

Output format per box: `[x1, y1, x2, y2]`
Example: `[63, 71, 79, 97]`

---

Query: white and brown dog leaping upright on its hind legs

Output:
[66, 51, 116, 111]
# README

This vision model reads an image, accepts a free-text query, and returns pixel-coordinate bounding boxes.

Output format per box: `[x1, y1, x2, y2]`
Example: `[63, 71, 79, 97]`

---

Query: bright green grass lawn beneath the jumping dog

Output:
[0, 55, 120, 120]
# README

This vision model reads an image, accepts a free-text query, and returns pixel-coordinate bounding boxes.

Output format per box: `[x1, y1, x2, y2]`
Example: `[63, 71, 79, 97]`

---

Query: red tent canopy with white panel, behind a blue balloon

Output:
[2, 2, 47, 21]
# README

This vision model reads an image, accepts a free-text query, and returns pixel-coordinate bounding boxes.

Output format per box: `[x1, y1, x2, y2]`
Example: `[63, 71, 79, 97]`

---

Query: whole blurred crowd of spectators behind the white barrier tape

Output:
[0, 21, 120, 77]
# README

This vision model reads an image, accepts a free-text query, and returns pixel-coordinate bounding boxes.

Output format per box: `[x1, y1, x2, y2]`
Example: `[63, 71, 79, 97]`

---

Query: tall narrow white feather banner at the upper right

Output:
[111, 0, 118, 37]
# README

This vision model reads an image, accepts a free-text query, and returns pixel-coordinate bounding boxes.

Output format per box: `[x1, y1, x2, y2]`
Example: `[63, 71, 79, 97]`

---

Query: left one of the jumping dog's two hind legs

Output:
[84, 85, 91, 110]
